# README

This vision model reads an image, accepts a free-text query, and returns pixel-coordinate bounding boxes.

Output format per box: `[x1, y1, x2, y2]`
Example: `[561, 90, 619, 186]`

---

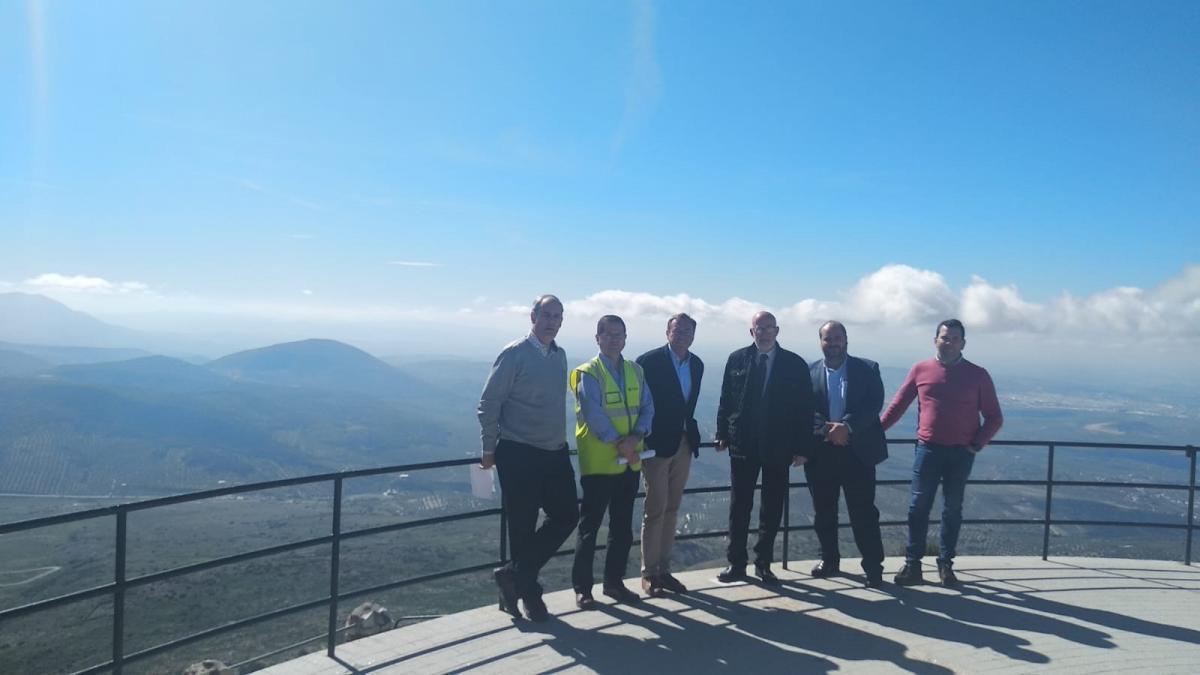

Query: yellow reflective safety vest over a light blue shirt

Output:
[571, 357, 646, 476]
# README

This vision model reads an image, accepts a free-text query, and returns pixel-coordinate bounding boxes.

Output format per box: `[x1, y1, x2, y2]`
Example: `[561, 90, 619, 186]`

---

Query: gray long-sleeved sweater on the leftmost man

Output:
[476, 338, 566, 453]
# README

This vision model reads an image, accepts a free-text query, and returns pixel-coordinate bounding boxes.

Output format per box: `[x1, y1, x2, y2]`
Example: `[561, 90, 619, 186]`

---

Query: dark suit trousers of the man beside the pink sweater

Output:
[804, 443, 883, 573]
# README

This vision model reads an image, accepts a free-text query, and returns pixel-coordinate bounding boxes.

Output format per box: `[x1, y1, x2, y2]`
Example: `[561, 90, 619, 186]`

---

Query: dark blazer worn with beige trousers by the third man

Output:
[637, 345, 704, 458]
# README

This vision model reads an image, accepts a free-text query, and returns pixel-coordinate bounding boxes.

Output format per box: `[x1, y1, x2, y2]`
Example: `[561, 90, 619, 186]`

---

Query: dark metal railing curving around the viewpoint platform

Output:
[0, 438, 1196, 675]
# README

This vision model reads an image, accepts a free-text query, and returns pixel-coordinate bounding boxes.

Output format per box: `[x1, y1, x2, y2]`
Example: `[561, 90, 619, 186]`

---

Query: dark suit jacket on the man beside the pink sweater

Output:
[810, 356, 888, 466]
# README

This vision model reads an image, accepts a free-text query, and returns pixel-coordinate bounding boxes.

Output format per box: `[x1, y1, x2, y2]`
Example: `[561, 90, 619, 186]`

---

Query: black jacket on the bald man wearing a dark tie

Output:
[716, 344, 817, 464]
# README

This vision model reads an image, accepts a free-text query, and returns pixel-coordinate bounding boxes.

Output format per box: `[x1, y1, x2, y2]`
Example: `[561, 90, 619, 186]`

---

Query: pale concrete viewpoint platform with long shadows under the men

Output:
[259, 557, 1200, 675]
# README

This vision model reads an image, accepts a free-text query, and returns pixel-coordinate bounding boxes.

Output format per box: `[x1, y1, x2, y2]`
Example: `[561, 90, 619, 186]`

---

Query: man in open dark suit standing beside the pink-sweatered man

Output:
[804, 321, 888, 589]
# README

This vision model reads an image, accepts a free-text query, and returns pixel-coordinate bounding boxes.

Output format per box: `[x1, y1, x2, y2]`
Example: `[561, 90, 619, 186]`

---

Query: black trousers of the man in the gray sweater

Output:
[496, 440, 580, 598]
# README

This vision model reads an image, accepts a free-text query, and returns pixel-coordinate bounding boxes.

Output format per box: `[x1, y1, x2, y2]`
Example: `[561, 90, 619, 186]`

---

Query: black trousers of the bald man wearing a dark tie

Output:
[726, 455, 791, 566]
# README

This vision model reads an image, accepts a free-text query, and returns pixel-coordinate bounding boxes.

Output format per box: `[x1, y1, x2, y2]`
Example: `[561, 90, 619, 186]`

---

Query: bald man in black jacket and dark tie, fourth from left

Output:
[716, 311, 815, 584]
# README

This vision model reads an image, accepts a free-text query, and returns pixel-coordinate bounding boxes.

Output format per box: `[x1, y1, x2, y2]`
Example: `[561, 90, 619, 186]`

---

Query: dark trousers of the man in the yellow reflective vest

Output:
[571, 468, 642, 592]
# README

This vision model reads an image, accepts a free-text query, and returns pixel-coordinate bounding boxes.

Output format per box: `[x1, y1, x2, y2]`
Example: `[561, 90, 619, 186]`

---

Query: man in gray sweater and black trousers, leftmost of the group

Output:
[478, 295, 580, 621]
